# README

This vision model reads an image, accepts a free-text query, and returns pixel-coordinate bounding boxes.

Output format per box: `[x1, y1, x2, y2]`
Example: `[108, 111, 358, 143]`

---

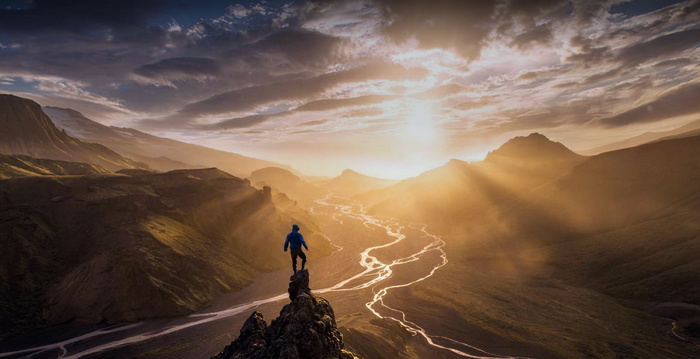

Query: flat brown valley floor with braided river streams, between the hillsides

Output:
[0, 201, 700, 359]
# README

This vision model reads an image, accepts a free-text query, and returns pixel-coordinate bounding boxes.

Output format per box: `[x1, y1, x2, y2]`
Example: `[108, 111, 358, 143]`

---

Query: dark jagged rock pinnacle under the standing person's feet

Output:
[212, 269, 358, 359]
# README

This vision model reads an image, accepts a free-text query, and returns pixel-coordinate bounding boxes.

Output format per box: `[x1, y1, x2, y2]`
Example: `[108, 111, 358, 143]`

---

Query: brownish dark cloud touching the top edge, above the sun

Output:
[375, 0, 610, 59]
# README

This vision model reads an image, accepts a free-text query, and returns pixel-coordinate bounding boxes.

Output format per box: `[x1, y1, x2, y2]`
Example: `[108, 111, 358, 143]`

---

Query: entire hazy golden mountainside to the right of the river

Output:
[361, 136, 700, 358]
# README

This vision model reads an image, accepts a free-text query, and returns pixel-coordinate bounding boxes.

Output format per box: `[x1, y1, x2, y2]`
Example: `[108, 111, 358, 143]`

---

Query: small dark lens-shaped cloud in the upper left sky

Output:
[134, 57, 221, 79]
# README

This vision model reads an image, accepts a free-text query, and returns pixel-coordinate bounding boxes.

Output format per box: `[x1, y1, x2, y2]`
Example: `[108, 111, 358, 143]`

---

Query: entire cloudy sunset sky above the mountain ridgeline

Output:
[0, 0, 700, 178]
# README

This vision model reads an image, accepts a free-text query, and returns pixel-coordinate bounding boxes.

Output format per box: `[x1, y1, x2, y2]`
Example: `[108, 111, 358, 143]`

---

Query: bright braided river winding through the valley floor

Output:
[0, 196, 522, 359]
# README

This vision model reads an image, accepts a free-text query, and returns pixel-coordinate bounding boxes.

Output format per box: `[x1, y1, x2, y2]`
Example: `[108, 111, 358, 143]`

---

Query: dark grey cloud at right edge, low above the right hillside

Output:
[600, 83, 700, 127]
